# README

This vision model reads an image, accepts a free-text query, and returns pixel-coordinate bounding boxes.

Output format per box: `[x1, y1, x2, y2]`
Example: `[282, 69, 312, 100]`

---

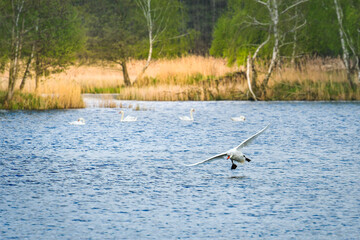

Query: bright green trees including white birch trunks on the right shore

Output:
[210, 0, 360, 99]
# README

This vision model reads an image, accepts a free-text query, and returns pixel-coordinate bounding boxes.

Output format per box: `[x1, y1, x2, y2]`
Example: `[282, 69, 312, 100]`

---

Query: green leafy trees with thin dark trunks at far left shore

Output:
[0, 0, 85, 101]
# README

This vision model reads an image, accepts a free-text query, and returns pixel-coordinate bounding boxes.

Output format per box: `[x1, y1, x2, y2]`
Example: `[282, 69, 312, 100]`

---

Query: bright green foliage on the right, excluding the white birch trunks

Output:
[210, 0, 360, 64]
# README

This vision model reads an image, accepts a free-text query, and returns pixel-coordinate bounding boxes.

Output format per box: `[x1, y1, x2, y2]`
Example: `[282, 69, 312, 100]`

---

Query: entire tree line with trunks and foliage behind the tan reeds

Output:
[0, 0, 360, 100]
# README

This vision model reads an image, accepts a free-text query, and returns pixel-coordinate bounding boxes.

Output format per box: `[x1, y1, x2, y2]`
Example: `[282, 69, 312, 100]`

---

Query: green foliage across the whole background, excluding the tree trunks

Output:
[0, 0, 360, 71]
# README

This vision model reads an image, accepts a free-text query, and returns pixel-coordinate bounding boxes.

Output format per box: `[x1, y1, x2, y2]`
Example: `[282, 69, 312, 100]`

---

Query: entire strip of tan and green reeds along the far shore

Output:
[0, 56, 360, 110]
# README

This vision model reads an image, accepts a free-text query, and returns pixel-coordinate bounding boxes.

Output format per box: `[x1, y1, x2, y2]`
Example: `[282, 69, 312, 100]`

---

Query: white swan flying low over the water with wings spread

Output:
[186, 124, 270, 169]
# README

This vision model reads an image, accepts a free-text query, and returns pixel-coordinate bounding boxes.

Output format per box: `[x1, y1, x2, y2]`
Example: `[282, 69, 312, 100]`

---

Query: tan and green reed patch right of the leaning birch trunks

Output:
[266, 58, 360, 101]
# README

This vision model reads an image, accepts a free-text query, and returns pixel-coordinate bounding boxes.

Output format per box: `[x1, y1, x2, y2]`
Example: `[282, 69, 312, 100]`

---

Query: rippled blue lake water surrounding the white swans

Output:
[0, 96, 360, 239]
